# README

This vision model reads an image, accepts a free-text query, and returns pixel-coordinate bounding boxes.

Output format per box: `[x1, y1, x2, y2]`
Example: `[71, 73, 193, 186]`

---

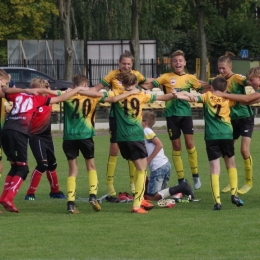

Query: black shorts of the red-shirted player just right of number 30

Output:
[29, 135, 56, 164]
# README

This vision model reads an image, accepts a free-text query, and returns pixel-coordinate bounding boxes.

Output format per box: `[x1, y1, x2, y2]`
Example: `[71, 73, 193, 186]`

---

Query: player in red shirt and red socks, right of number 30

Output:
[25, 78, 66, 200]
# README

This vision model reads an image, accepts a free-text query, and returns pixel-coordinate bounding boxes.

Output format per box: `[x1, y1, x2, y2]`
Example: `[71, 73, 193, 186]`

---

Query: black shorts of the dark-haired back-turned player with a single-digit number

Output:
[206, 139, 235, 161]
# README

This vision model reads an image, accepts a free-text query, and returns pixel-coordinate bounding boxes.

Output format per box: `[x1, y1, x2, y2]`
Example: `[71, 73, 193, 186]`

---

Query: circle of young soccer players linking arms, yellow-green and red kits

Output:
[0, 48, 258, 214]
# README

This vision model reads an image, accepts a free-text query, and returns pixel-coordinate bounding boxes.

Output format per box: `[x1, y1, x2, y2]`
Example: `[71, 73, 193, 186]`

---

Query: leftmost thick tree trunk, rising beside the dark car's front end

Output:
[59, 0, 74, 81]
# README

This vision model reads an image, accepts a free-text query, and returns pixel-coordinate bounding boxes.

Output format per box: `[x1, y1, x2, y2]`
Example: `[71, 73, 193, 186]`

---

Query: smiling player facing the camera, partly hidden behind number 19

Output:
[92, 50, 153, 202]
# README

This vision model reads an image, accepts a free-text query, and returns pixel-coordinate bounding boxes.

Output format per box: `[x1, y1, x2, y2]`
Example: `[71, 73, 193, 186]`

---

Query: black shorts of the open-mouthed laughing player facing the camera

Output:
[166, 116, 193, 140]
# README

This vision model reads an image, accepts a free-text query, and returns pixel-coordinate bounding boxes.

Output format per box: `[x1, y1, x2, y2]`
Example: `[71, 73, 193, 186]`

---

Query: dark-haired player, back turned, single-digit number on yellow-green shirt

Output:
[175, 77, 244, 210]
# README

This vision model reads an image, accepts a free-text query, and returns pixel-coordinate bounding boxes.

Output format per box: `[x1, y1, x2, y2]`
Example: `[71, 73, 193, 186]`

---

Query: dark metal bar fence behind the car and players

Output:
[0, 59, 170, 86]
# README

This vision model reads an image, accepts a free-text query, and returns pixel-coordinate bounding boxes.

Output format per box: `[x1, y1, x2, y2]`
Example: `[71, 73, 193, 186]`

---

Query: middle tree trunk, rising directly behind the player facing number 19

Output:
[129, 0, 142, 71]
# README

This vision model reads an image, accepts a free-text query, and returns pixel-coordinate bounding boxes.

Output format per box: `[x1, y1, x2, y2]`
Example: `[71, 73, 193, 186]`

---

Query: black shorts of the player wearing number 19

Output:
[117, 141, 148, 161]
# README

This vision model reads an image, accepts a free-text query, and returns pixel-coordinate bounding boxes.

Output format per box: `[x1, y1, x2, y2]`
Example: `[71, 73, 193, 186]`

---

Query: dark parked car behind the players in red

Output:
[1, 67, 72, 90]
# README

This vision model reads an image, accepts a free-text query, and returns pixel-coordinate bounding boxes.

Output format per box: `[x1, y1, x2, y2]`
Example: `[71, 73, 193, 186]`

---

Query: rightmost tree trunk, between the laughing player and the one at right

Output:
[198, 8, 207, 81]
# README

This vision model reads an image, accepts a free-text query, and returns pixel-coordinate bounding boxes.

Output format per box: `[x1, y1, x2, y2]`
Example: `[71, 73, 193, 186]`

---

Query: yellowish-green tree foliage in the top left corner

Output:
[0, 0, 58, 40]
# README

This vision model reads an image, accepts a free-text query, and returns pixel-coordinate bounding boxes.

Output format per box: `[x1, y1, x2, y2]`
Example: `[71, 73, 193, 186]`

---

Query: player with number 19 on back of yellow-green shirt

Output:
[106, 72, 179, 214]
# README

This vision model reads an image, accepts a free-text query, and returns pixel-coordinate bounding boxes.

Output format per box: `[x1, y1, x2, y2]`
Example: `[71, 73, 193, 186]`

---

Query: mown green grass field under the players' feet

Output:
[0, 130, 260, 260]
